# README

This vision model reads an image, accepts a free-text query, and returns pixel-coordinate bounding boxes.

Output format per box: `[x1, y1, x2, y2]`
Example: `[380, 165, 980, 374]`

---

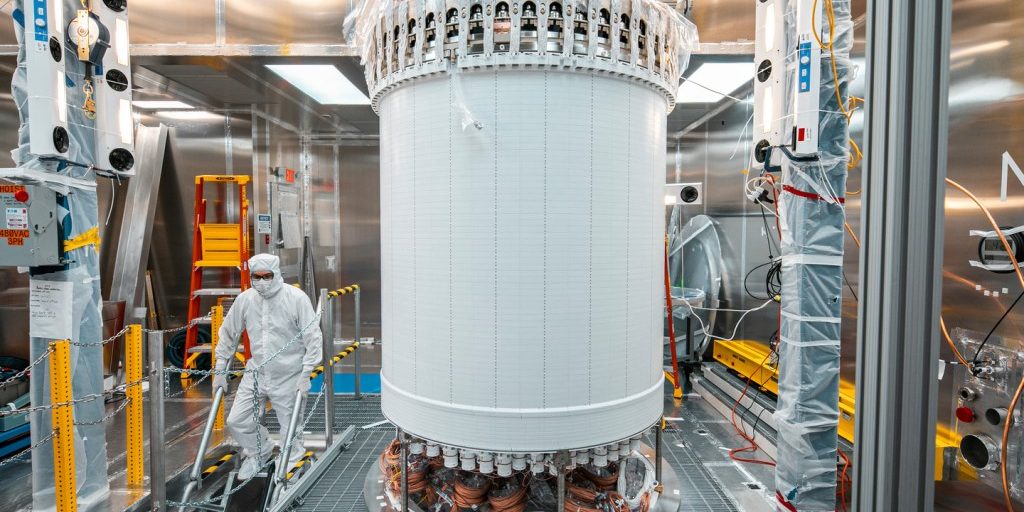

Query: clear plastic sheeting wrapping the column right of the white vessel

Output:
[774, 0, 853, 512]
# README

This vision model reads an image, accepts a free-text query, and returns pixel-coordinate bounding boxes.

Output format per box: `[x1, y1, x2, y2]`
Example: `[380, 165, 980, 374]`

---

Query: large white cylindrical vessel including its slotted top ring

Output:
[356, 2, 700, 458]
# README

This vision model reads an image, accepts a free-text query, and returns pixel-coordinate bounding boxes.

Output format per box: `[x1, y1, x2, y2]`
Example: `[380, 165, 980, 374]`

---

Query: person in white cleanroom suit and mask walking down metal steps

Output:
[213, 254, 323, 480]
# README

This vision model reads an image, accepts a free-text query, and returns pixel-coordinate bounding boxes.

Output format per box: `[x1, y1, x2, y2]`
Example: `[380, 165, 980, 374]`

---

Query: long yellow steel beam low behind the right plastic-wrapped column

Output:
[713, 340, 971, 479]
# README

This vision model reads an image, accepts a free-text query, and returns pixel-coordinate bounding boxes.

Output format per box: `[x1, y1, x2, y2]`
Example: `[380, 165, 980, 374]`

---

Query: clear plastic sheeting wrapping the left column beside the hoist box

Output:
[11, 0, 110, 511]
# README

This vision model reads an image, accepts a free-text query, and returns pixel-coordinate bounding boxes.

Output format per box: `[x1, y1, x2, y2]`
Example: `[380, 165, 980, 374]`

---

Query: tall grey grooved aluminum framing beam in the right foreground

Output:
[853, 0, 951, 510]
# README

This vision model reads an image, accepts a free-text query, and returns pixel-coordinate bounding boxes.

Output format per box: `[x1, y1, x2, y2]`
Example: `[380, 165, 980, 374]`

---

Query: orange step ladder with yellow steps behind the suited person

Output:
[184, 174, 252, 369]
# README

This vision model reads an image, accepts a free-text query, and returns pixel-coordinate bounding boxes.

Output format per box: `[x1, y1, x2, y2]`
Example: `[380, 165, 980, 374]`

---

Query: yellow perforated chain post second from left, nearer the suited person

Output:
[125, 324, 145, 485]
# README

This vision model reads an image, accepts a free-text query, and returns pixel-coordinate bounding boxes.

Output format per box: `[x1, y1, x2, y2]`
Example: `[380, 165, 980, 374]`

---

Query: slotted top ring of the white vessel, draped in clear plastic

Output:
[353, 0, 696, 111]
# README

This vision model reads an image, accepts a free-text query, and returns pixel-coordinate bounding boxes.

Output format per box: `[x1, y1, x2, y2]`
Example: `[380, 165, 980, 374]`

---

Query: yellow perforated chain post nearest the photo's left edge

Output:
[50, 340, 78, 512]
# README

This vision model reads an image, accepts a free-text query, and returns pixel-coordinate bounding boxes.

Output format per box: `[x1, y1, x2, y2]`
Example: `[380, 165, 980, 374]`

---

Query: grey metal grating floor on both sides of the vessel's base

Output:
[284, 395, 772, 512]
